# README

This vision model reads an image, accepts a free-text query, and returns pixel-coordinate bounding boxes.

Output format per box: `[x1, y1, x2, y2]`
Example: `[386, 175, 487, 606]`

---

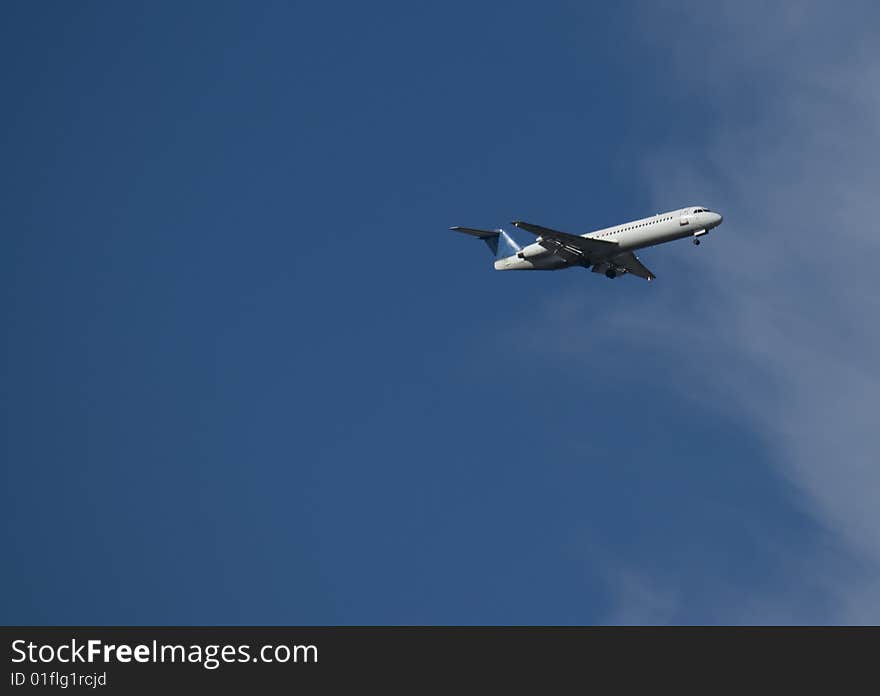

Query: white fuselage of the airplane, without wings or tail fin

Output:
[495, 206, 723, 271]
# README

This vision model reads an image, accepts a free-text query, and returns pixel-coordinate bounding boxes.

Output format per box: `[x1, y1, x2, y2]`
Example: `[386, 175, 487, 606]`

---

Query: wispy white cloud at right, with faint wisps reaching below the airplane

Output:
[536, 2, 880, 623]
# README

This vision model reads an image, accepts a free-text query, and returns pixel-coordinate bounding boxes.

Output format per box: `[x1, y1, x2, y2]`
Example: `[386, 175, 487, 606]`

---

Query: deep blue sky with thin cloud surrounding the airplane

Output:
[0, 2, 880, 624]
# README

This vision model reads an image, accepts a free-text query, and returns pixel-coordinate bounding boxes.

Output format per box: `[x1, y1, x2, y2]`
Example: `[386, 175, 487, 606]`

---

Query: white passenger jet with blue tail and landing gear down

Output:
[449, 206, 724, 280]
